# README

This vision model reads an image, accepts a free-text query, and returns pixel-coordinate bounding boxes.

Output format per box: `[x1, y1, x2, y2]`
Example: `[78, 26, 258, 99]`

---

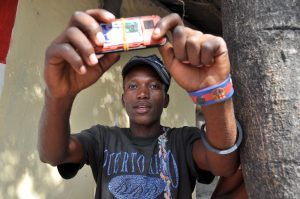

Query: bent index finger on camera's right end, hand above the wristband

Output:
[152, 13, 184, 39]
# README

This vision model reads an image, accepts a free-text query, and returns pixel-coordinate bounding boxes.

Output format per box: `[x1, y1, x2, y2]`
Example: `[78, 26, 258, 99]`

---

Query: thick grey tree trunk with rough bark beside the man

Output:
[222, 0, 300, 199]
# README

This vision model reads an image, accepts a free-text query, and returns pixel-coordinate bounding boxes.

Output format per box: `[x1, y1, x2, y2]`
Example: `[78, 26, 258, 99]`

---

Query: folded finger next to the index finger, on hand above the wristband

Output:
[173, 26, 187, 61]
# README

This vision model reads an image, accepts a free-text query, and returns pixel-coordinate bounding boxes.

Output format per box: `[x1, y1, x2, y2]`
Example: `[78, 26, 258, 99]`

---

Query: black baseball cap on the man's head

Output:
[122, 54, 171, 92]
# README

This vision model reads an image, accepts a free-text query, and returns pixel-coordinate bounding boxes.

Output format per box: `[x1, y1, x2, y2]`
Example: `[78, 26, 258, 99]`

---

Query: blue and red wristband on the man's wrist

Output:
[189, 75, 234, 106]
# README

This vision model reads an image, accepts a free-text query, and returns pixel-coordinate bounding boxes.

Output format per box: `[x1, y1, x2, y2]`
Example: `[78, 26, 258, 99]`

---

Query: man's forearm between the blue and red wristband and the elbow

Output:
[202, 99, 238, 176]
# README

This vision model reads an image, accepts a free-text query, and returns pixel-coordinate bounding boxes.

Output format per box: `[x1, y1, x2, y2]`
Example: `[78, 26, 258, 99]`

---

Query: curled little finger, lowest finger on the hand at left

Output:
[46, 43, 86, 74]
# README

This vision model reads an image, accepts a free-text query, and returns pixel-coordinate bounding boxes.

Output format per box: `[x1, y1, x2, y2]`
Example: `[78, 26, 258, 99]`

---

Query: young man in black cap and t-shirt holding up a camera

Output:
[38, 9, 239, 198]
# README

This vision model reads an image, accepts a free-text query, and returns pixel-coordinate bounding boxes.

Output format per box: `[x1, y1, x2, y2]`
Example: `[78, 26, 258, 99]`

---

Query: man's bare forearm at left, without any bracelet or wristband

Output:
[38, 91, 74, 165]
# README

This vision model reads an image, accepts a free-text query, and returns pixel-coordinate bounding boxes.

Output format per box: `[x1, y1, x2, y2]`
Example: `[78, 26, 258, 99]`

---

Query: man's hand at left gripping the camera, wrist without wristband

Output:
[44, 9, 119, 98]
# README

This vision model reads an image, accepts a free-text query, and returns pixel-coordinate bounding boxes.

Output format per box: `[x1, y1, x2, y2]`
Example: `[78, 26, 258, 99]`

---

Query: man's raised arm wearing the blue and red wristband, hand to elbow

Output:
[152, 14, 238, 176]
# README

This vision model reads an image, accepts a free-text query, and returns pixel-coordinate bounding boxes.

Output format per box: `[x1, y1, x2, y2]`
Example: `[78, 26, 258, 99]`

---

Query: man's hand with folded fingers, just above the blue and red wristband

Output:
[152, 14, 230, 92]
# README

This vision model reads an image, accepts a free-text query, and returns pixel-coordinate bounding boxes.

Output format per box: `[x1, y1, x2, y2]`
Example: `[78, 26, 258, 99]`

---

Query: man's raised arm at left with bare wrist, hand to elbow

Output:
[38, 9, 119, 165]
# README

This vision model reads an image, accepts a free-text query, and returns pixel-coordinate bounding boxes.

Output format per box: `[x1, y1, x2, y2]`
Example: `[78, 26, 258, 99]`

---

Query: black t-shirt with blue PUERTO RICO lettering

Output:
[58, 125, 214, 199]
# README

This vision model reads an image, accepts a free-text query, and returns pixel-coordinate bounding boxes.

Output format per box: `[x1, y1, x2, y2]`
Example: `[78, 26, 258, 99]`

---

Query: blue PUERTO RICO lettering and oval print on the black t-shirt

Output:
[103, 128, 179, 199]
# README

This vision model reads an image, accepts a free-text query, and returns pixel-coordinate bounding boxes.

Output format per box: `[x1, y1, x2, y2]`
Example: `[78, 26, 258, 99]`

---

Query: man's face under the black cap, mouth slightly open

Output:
[122, 65, 169, 125]
